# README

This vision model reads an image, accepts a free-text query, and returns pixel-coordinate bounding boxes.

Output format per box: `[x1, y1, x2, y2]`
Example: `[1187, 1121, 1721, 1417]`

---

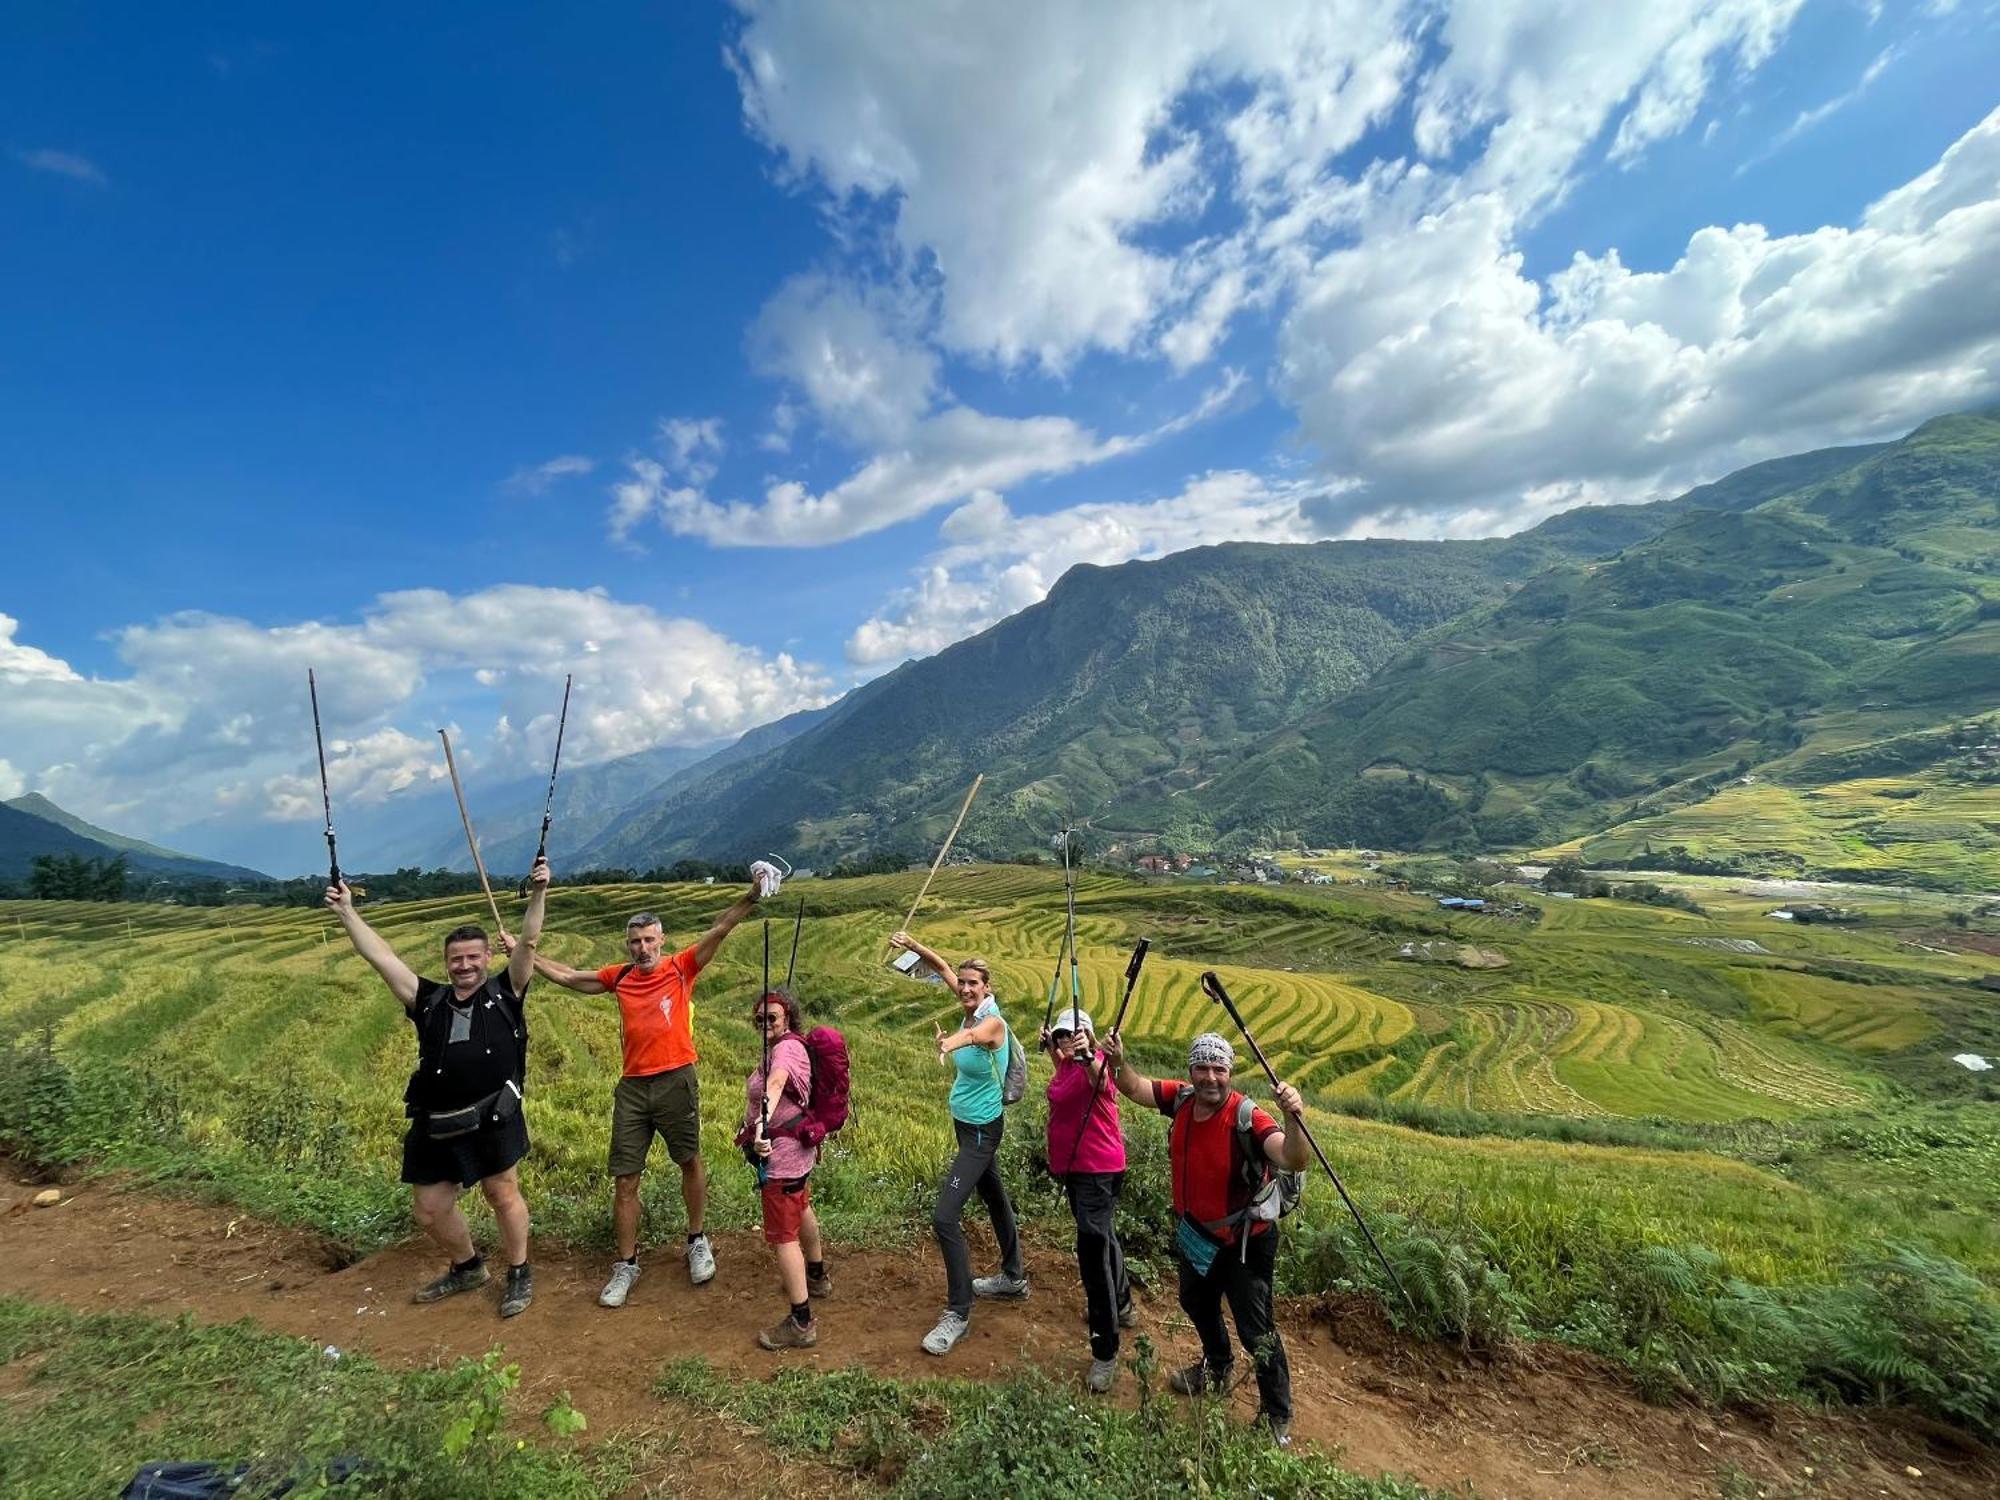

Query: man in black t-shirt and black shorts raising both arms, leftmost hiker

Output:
[326, 860, 548, 1318]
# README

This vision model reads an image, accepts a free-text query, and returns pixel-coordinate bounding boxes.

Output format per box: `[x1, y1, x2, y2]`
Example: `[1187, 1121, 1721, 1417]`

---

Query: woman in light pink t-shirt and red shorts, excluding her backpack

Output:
[742, 990, 834, 1350]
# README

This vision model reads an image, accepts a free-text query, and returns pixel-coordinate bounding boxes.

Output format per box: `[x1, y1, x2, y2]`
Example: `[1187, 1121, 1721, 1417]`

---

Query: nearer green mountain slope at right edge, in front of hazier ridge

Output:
[1204, 412, 2000, 880]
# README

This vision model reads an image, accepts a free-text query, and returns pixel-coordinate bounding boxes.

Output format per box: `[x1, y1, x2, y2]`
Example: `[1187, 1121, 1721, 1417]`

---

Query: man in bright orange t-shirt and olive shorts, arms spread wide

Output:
[534, 874, 776, 1308]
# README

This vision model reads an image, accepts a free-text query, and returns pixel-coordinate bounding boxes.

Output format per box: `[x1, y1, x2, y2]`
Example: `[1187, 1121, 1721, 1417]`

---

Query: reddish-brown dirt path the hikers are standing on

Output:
[0, 1170, 2000, 1500]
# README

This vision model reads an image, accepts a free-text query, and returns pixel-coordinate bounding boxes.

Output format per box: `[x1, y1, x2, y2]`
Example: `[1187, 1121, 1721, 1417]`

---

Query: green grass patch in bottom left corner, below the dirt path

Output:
[0, 1298, 640, 1500]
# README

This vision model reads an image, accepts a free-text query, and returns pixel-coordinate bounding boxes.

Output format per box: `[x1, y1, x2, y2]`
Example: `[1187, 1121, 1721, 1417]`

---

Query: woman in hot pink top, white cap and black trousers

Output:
[1042, 1010, 1138, 1394]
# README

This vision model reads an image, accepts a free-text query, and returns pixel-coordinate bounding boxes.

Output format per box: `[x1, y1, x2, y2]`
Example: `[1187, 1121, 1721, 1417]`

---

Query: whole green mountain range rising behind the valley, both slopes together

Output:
[532, 410, 2000, 880]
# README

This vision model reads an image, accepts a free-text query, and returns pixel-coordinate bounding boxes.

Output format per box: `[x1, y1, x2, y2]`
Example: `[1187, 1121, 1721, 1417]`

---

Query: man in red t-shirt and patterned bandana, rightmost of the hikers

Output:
[1104, 1032, 1310, 1446]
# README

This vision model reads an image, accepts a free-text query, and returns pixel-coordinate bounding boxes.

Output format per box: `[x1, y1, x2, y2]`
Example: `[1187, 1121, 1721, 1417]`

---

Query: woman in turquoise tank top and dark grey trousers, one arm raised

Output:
[890, 932, 1028, 1354]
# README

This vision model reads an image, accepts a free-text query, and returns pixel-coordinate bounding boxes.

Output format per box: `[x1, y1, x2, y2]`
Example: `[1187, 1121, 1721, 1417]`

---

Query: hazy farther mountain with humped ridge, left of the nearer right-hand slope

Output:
[586, 528, 1720, 866]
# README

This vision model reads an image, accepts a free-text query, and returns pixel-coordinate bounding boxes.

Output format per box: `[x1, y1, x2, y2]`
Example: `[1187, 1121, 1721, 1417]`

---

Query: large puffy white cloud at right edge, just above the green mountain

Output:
[1280, 110, 2000, 524]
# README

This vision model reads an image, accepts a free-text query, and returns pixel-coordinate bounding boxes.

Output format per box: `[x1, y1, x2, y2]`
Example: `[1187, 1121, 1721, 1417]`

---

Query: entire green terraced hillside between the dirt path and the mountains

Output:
[0, 866, 2000, 1432]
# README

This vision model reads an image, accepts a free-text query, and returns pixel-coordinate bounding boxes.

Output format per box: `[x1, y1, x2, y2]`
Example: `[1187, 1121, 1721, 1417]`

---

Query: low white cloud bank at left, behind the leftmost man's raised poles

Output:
[0, 584, 832, 848]
